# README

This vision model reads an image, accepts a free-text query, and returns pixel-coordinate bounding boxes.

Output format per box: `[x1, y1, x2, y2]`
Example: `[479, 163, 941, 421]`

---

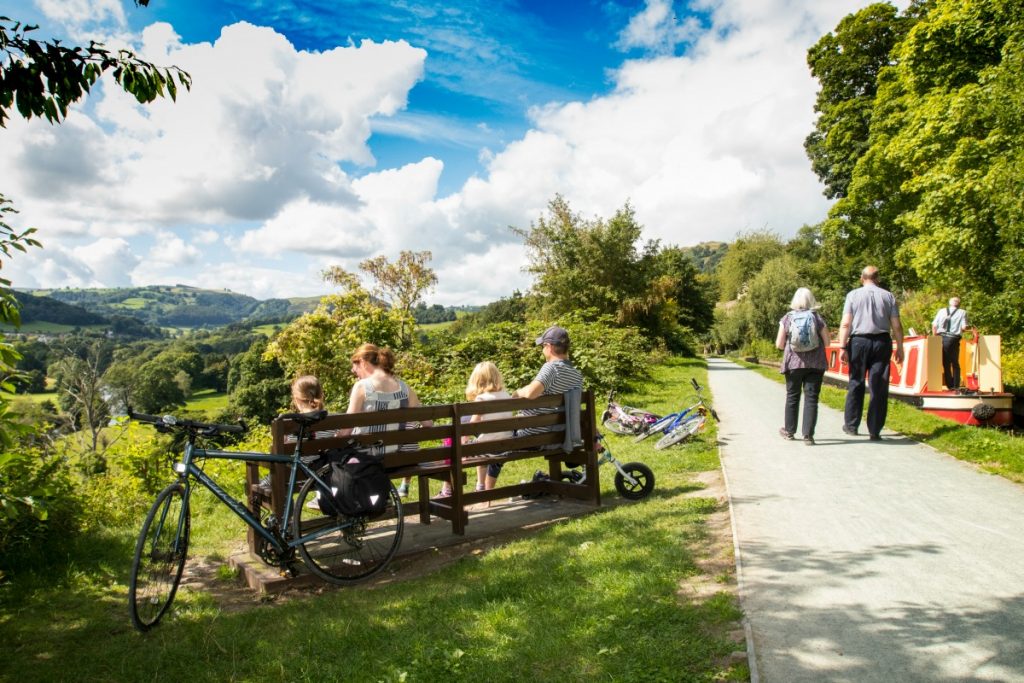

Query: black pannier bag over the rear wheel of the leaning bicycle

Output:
[317, 441, 391, 517]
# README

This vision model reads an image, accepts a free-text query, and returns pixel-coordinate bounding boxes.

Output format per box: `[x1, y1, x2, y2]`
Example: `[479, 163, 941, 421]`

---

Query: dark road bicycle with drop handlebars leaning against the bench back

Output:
[128, 411, 403, 631]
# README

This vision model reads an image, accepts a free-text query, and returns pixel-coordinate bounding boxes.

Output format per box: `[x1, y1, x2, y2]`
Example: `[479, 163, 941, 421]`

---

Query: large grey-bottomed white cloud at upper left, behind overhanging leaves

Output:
[0, 24, 426, 225]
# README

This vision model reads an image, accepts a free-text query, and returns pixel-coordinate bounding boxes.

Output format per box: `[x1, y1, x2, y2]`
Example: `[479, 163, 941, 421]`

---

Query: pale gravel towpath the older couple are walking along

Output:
[709, 359, 1024, 683]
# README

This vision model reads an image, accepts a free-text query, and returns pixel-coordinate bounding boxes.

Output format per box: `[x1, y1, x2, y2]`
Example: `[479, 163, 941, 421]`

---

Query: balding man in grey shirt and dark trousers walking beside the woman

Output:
[839, 265, 903, 441]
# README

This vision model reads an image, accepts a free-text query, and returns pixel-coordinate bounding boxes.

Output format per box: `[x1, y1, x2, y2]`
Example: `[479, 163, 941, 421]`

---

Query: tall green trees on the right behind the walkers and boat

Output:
[714, 0, 1024, 387]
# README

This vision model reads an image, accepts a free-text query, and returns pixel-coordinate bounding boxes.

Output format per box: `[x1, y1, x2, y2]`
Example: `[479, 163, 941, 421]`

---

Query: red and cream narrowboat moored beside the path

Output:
[825, 330, 1014, 426]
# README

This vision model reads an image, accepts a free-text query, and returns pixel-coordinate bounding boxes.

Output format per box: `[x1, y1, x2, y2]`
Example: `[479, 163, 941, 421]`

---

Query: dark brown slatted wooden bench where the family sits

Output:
[246, 391, 601, 551]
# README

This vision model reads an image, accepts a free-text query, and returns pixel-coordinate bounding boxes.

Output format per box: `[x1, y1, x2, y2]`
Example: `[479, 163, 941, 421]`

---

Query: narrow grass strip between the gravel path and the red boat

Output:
[733, 358, 1024, 483]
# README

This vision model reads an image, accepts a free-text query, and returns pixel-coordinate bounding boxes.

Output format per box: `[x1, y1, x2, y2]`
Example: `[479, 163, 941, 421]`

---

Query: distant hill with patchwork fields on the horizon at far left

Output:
[18, 285, 319, 328]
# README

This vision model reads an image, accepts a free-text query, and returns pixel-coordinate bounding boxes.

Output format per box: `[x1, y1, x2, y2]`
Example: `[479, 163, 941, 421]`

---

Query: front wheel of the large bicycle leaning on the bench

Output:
[128, 483, 189, 631]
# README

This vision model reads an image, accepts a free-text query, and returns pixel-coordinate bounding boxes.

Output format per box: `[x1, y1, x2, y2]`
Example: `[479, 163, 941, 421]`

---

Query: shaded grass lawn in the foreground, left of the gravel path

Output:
[0, 359, 748, 683]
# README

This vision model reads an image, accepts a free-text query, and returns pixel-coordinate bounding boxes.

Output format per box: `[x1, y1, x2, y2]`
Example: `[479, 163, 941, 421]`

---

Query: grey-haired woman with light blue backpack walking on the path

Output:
[775, 287, 829, 445]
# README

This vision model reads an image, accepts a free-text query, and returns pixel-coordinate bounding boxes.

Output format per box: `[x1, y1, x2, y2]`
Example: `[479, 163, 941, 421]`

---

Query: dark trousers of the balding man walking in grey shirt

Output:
[844, 335, 893, 436]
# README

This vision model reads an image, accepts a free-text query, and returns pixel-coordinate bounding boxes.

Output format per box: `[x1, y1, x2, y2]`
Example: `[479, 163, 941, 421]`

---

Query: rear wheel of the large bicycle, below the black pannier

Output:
[292, 466, 404, 584]
